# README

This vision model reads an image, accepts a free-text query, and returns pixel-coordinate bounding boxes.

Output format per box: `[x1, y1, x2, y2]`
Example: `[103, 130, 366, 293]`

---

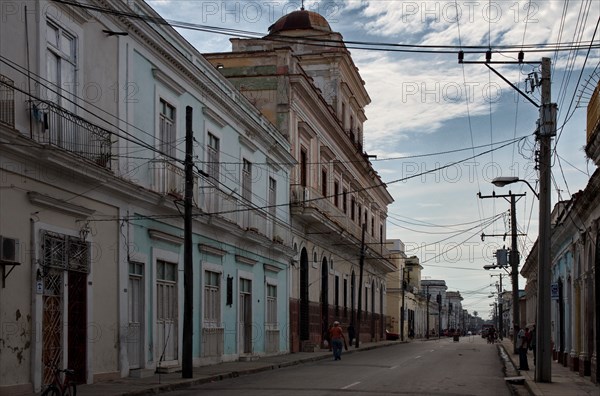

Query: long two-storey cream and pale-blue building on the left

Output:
[0, 0, 296, 394]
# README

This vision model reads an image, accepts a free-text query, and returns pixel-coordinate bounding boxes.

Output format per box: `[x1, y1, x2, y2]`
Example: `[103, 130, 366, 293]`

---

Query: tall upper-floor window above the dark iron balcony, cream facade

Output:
[46, 22, 77, 112]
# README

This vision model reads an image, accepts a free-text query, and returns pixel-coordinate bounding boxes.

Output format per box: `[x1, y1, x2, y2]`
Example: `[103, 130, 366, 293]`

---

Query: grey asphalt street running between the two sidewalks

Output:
[169, 336, 510, 396]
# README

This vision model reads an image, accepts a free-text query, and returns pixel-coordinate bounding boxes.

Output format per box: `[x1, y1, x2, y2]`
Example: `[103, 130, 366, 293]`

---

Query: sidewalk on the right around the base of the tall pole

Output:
[501, 338, 600, 396]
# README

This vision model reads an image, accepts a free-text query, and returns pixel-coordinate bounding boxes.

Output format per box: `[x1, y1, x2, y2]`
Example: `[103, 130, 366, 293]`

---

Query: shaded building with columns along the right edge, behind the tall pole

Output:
[521, 78, 600, 383]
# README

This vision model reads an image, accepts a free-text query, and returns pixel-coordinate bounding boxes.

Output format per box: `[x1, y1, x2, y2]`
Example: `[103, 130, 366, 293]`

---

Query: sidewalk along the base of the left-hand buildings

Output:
[77, 341, 400, 396]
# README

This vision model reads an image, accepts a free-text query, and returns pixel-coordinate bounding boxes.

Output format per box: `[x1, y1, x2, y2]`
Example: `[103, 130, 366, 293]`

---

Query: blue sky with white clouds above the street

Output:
[147, 0, 600, 318]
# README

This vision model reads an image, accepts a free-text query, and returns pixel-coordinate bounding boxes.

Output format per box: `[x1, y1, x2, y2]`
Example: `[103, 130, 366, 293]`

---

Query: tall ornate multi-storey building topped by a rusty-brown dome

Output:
[205, 9, 395, 351]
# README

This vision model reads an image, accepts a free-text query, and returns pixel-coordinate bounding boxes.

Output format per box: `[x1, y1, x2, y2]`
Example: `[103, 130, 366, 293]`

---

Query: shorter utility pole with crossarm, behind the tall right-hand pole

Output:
[477, 191, 525, 354]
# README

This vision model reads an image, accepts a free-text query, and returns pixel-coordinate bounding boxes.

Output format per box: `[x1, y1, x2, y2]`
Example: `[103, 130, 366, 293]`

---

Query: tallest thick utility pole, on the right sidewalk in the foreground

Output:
[535, 58, 556, 382]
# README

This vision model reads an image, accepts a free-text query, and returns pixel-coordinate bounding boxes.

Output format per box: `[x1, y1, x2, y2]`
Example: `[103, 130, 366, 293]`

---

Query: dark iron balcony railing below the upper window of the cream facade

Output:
[31, 101, 112, 169]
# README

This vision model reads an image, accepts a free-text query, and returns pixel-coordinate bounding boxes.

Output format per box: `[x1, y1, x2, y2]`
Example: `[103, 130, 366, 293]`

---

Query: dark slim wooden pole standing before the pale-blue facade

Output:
[181, 106, 194, 378]
